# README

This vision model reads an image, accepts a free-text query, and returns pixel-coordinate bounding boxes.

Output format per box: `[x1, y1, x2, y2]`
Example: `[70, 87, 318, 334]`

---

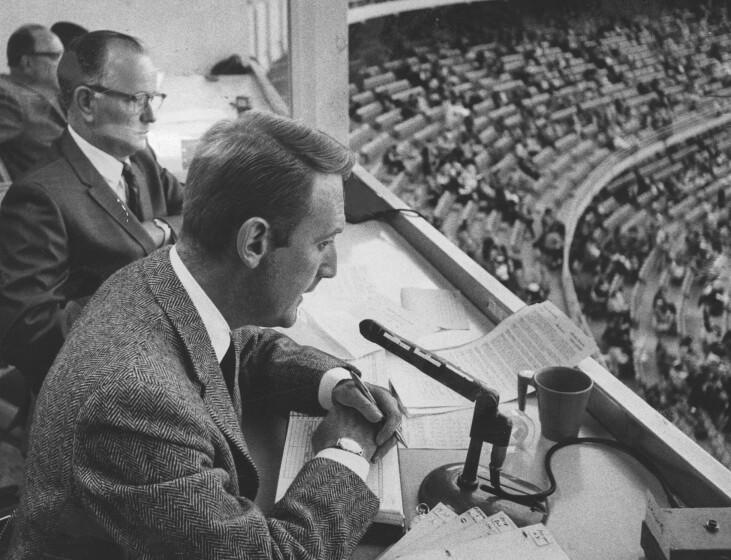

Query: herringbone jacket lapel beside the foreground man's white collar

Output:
[146, 249, 259, 499]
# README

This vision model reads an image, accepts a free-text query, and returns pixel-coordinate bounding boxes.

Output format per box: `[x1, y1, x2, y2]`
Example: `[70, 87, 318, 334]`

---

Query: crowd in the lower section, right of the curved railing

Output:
[571, 132, 731, 456]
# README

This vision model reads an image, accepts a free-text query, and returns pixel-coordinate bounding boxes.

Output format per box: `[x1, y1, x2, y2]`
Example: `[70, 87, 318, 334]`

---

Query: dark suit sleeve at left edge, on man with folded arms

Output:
[0, 179, 77, 390]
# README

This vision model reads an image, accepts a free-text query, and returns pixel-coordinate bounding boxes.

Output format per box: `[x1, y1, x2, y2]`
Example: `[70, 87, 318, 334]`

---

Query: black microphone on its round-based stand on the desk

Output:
[360, 319, 548, 527]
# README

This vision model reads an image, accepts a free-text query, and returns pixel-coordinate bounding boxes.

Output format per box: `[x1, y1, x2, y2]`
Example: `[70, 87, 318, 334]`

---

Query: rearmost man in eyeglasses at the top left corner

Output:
[0, 24, 66, 180]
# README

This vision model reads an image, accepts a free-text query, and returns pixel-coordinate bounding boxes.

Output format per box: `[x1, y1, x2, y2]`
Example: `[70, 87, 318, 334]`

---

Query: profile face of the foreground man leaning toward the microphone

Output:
[258, 173, 345, 327]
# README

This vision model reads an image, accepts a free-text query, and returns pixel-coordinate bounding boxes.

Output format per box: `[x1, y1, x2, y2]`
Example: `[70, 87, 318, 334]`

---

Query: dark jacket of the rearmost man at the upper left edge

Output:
[0, 75, 66, 180]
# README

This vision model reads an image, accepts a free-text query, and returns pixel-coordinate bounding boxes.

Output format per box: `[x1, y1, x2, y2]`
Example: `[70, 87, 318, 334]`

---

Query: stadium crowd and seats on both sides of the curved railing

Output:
[351, 1, 731, 460]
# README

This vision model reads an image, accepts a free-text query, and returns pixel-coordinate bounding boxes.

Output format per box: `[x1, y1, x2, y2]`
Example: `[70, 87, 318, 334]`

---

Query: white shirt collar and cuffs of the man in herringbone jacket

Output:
[170, 246, 370, 480]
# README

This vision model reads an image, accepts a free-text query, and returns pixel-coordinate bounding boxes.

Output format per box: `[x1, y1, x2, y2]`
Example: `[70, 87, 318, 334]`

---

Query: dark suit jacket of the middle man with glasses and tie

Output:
[0, 132, 182, 390]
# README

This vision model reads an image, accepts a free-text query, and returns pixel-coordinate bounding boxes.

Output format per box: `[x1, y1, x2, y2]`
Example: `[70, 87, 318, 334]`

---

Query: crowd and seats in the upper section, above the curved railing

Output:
[350, 0, 729, 304]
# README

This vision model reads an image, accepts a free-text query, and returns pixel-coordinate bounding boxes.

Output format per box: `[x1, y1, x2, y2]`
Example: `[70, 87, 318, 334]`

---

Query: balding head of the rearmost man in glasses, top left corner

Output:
[7, 24, 63, 92]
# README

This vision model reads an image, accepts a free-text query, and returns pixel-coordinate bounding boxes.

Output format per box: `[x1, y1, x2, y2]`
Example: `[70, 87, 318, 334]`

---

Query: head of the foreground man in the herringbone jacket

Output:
[178, 111, 354, 328]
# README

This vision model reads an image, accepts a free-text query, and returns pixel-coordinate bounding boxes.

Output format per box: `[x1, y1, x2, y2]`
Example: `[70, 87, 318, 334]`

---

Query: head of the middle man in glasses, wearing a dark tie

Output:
[58, 30, 165, 160]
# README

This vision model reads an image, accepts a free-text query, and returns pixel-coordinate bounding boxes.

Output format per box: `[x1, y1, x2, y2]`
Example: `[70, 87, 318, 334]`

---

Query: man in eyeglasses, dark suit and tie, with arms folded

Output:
[0, 31, 182, 391]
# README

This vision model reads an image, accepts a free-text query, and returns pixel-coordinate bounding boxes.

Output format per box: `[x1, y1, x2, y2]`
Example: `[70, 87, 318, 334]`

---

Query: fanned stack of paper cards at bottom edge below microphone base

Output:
[378, 504, 569, 560]
